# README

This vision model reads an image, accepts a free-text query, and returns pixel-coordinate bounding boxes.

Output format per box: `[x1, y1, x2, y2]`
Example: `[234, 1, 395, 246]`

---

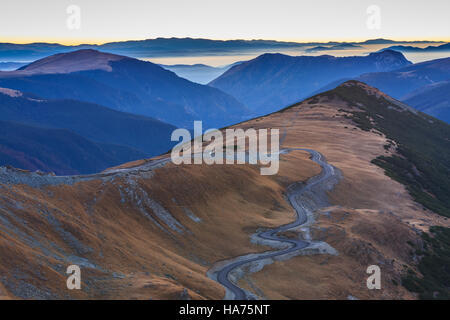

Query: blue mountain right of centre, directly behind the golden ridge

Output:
[209, 50, 411, 114]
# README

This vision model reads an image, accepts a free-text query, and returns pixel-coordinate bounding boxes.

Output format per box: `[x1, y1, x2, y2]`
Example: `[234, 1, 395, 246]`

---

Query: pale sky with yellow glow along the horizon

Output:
[0, 0, 450, 44]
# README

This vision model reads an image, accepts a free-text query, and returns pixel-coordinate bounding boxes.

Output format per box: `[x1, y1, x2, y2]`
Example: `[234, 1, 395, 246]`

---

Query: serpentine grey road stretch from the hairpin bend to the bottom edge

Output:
[209, 148, 340, 300]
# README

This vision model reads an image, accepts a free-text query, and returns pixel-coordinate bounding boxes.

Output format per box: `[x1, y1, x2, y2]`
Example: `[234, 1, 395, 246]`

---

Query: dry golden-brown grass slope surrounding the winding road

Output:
[0, 80, 449, 299]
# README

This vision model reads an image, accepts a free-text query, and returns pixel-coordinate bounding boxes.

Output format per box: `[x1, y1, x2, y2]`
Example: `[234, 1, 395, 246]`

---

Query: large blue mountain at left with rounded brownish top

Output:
[0, 49, 247, 127]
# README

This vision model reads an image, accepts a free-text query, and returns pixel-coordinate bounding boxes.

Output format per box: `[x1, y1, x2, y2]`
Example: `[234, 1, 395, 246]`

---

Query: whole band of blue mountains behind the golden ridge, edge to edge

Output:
[0, 45, 450, 174]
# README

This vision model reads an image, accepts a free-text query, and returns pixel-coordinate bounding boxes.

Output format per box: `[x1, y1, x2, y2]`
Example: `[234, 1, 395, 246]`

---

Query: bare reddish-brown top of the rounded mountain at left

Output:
[17, 49, 127, 74]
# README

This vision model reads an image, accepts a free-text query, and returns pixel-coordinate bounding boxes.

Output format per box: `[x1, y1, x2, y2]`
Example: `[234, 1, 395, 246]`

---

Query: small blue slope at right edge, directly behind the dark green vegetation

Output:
[403, 81, 450, 123]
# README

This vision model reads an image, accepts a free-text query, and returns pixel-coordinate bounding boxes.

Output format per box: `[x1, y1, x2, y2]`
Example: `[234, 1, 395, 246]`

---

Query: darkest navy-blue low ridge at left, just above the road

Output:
[0, 120, 144, 175]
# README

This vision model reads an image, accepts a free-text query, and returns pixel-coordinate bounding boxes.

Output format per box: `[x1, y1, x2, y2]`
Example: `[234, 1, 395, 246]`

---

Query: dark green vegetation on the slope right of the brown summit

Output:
[326, 81, 450, 217]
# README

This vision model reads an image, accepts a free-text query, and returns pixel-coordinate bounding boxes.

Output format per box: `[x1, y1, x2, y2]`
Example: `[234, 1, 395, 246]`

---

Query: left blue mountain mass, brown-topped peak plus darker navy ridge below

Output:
[0, 49, 248, 175]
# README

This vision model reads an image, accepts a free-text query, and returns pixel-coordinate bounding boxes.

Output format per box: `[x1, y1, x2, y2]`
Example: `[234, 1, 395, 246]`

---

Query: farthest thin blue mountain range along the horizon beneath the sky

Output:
[0, 38, 442, 61]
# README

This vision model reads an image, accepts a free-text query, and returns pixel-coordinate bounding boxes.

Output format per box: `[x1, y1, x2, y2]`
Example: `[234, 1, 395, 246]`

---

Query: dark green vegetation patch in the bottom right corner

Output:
[402, 227, 450, 299]
